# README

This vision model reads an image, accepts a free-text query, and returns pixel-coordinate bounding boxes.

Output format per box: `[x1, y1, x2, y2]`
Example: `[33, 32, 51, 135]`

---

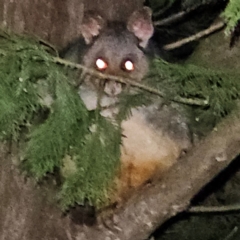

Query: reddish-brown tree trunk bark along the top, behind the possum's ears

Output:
[0, 0, 144, 49]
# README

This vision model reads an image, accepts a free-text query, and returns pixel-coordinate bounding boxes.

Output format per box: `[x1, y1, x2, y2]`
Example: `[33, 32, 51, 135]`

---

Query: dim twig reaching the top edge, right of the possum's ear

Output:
[153, 1, 213, 27]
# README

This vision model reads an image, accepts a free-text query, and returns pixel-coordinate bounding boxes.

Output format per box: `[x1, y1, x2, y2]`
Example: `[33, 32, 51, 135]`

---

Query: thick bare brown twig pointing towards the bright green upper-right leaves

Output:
[163, 22, 225, 50]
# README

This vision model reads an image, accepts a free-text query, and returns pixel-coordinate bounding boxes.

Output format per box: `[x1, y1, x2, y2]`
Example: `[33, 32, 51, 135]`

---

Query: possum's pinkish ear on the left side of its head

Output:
[81, 11, 105, 44]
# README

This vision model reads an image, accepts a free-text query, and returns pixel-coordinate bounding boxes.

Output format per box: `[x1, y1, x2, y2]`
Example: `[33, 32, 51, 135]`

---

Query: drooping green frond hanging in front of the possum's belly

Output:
[60, 115, 121, 209]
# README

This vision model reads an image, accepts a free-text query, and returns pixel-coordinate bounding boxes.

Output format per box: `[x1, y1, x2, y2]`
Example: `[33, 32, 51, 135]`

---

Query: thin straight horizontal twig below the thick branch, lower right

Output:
[188, 204, 240, 213]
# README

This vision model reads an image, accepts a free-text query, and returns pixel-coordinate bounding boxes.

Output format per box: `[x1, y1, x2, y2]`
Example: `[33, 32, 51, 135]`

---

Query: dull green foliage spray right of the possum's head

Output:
[147, 59, 240, 131]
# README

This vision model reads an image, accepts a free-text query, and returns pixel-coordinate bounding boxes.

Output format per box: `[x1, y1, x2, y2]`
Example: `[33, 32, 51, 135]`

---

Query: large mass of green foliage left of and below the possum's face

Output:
[0, 33, 121, 209]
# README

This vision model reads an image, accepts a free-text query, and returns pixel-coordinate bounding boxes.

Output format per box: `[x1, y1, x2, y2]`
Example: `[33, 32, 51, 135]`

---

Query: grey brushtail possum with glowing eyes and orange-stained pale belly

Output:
[63, 7, 190, 202]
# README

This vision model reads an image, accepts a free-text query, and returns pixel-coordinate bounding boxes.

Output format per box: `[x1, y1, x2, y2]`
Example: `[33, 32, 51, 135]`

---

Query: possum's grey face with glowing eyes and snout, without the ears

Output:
[83, 26, 148, 96]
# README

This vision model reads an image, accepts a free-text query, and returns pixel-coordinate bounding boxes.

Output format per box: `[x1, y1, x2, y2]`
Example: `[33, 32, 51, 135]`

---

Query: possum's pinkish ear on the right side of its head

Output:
[127, 7, 154, 48]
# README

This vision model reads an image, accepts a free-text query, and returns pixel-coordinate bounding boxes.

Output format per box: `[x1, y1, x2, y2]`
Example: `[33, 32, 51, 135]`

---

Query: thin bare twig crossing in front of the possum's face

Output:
[53, 57, 209, 106]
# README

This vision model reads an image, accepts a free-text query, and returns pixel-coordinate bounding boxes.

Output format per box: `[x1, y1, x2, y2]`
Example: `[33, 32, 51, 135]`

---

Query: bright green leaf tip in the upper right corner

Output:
[222, 0, 240, 35]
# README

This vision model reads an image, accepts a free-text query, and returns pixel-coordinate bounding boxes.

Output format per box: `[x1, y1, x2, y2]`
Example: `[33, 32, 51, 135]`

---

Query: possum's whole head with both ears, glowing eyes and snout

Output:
[81, 7, 153, 96]
